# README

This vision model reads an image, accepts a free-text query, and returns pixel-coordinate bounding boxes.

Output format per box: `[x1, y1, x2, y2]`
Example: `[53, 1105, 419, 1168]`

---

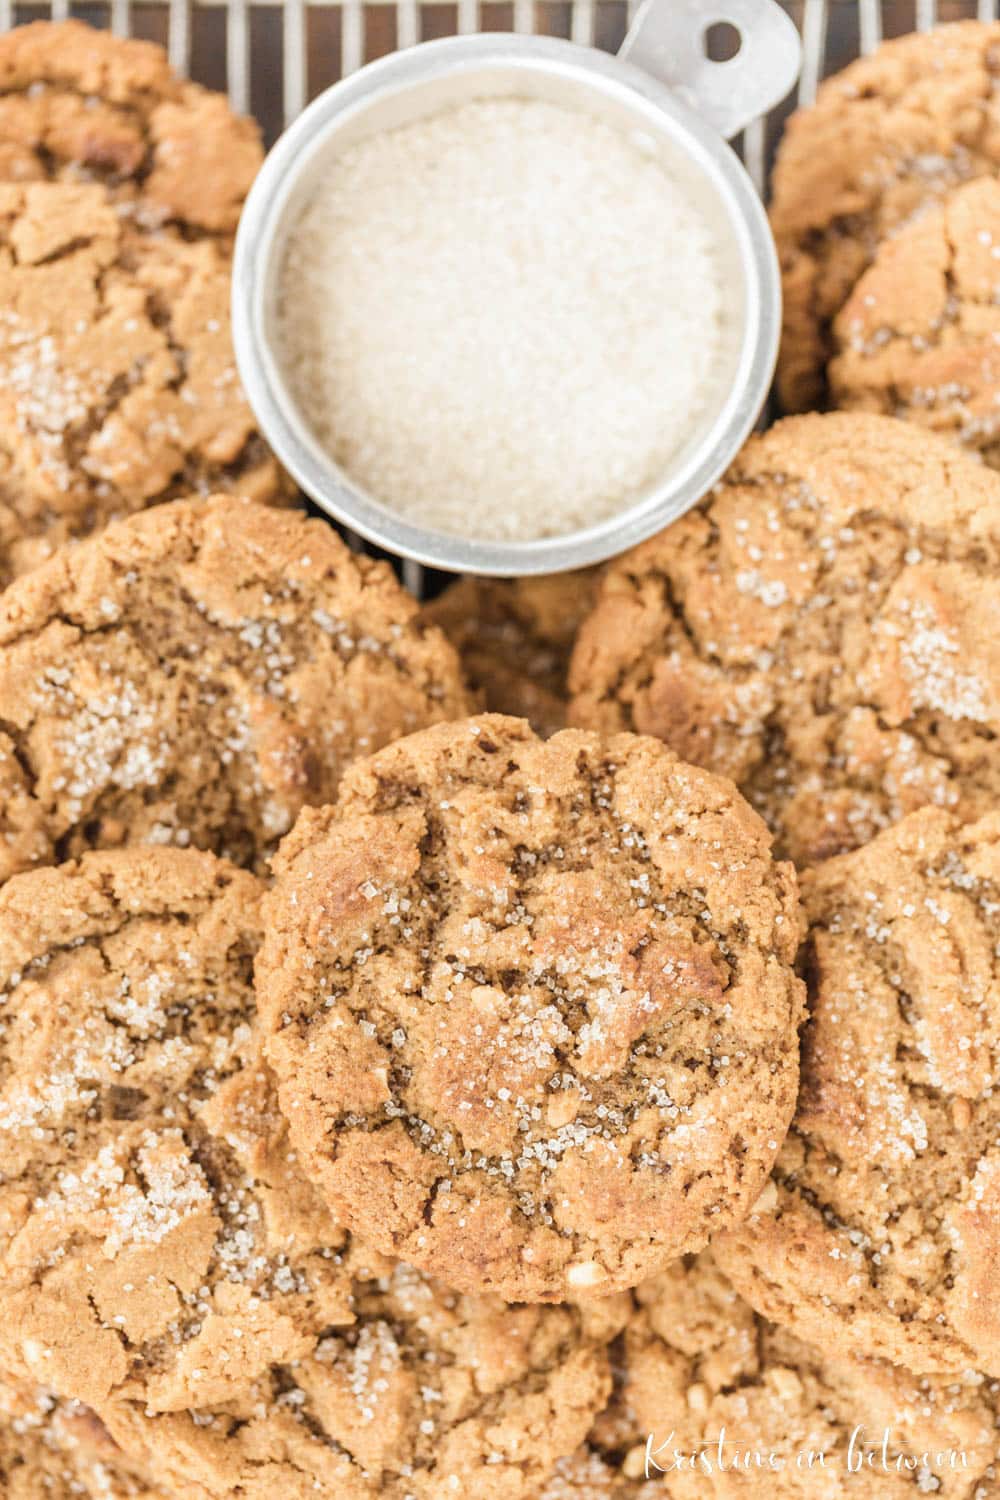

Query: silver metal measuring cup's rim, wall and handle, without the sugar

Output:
[232, 0, 801, 576]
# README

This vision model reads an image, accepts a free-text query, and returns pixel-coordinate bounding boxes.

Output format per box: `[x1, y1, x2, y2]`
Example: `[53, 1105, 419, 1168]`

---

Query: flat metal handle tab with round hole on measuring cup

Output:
[618, 0, 802, 140]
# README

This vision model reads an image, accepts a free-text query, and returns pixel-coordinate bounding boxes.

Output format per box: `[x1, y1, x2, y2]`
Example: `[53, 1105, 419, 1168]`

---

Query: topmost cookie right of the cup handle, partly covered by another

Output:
[771, 21, 1000, 411]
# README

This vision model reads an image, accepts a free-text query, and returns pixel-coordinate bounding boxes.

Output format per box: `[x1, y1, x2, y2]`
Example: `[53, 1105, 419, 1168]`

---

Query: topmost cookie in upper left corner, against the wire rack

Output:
[0, 21, 264, 237]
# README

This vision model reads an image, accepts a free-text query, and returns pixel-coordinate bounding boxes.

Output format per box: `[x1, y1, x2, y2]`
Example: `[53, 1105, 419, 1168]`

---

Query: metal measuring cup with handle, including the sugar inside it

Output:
[234, 0, 799, 575]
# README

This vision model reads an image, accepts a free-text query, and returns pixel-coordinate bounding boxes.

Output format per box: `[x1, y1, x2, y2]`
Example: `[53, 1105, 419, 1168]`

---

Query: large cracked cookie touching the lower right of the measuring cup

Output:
[570, 413, 1000, 866]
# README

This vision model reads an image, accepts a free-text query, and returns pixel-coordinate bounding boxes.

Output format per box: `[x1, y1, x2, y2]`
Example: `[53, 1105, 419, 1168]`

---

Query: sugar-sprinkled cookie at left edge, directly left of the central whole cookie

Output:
[0, 849, 359, 1412]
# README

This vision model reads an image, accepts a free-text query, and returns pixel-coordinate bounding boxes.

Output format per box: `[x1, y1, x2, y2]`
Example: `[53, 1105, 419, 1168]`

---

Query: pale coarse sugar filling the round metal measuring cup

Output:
[277, 98, 724, 542]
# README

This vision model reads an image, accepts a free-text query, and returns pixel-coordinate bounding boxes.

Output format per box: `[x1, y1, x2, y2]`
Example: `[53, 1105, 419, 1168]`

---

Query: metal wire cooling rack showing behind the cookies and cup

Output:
[0, 0, 1000, 596]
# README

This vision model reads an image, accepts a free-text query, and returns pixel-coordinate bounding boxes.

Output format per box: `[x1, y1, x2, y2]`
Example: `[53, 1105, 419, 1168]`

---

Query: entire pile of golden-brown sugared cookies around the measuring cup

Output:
[0, 11, 1000, 1500]
